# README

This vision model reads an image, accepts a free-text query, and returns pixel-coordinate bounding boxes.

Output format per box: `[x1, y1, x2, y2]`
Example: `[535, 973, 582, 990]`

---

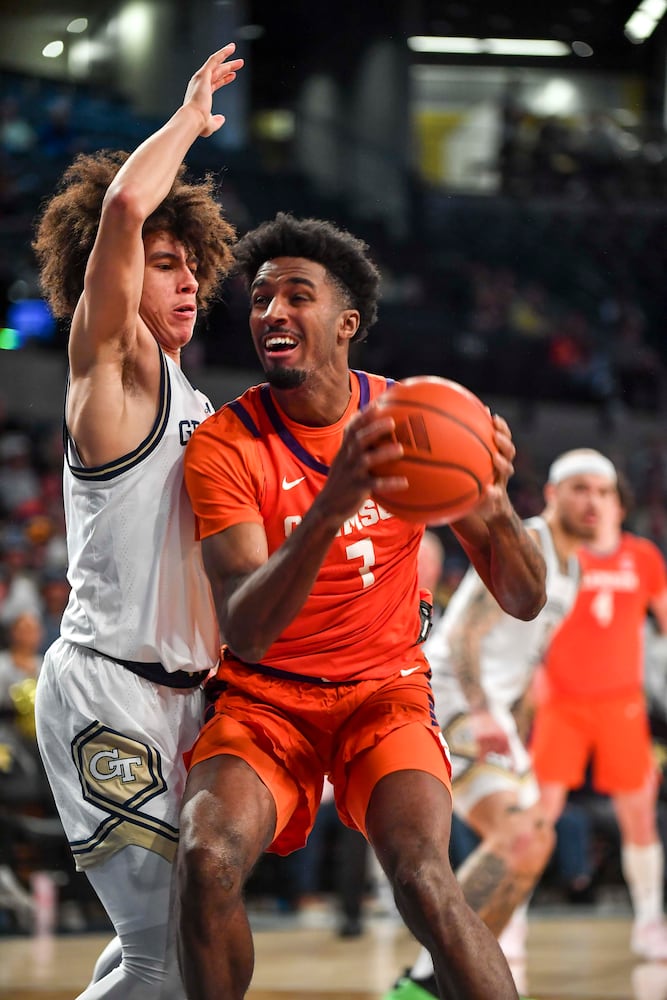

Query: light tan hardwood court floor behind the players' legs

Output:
[0, 908, 667, 1000]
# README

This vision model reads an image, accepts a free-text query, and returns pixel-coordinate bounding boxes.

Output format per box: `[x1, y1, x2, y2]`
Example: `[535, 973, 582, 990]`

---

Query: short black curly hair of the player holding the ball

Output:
[233, 212, 380, 341]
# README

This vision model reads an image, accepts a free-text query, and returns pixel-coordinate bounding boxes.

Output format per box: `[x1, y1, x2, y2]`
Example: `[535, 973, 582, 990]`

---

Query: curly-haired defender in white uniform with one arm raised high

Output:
[34, 45, 242, 1000]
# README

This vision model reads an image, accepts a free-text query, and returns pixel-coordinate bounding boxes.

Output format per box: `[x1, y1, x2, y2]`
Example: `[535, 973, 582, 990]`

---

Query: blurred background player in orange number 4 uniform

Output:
[531, 452, 667, 960]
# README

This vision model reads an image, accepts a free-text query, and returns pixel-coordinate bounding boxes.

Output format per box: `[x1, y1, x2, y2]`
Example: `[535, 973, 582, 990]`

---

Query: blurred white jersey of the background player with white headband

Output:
[424, 517, 579, 722]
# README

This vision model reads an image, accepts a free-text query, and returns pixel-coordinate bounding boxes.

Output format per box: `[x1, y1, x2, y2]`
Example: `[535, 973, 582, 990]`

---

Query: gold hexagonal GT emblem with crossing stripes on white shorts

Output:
[70, 722, 178, 868]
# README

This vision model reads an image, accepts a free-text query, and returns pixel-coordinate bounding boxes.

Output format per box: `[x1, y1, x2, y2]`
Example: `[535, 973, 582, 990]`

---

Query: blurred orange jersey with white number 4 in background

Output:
[545, 533, 667, 697]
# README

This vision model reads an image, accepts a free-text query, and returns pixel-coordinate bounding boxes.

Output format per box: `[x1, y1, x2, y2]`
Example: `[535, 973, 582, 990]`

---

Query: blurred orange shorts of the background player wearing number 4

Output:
[530, 692, 657, 795]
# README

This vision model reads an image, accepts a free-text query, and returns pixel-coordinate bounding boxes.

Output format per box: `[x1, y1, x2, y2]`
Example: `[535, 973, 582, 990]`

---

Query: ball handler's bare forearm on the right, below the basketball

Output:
[457, 510, 546, 621]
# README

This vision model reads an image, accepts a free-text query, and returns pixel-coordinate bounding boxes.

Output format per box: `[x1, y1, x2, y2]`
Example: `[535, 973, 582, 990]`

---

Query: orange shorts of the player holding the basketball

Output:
[187, 660, 451, 854]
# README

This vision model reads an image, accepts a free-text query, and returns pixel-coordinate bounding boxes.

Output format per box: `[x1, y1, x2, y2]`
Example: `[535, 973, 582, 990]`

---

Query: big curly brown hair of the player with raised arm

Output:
[32, 150, 236, 318]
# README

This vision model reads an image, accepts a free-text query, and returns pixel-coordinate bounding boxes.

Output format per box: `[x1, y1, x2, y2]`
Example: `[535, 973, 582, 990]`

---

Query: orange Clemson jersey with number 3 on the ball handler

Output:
[185, 372, 425, 682]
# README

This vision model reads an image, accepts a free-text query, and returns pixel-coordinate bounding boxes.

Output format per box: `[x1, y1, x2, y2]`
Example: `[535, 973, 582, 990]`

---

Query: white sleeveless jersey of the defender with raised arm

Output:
[61, 351, 219, 672]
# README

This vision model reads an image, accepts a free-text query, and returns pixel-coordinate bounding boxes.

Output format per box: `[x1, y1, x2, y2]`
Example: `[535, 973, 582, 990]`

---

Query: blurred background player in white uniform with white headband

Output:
[385, 449, 616, 1000]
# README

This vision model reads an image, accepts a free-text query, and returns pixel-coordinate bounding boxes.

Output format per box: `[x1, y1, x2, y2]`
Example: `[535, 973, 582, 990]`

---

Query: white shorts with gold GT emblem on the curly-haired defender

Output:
[35, 639, 204, 870]
